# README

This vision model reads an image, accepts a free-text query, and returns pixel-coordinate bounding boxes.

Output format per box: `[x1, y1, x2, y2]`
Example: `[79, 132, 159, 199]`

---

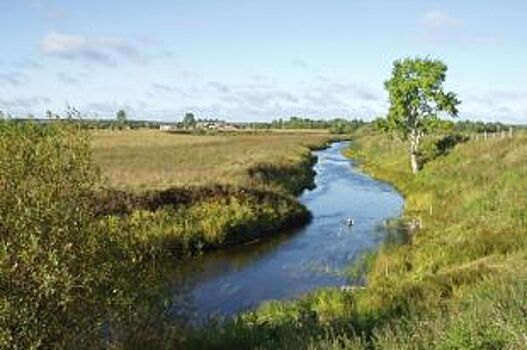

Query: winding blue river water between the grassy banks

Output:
[169, 142, 403, 319]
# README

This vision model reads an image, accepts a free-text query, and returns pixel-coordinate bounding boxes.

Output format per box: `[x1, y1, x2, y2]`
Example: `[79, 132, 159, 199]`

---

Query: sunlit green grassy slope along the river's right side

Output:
[190, 129, 527, 349]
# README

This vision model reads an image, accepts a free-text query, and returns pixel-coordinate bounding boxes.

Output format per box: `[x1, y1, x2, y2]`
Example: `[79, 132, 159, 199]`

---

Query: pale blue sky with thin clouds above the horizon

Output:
[0, 0, 527, 123]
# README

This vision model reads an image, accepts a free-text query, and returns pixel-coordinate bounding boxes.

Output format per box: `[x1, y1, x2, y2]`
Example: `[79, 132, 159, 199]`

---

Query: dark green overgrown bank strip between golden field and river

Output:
[98, 136, 344, 257]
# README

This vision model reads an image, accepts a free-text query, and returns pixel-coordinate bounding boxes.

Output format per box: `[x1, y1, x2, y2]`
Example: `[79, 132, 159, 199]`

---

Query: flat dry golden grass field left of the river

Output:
[93, 130, 329, 190]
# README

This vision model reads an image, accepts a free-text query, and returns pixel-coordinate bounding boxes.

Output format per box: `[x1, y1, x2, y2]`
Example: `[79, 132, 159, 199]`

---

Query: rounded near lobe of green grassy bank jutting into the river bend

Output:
[95, 182, 311, 258]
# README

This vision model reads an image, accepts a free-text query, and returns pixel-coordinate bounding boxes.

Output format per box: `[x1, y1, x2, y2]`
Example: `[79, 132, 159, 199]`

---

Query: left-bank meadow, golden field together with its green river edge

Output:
[92, 130, 330, 256]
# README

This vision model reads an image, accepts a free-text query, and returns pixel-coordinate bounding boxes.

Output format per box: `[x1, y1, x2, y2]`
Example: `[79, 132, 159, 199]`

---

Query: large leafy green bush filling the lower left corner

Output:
[0, 120, 140, 349]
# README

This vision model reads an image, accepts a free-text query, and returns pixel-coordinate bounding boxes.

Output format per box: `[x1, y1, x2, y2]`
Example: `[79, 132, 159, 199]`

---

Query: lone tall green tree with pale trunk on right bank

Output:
[381, 58, 461, 173]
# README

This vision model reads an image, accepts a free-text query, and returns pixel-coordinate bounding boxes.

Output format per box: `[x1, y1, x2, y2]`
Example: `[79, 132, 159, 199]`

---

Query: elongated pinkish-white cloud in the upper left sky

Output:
[40, 31, 145, 66]
